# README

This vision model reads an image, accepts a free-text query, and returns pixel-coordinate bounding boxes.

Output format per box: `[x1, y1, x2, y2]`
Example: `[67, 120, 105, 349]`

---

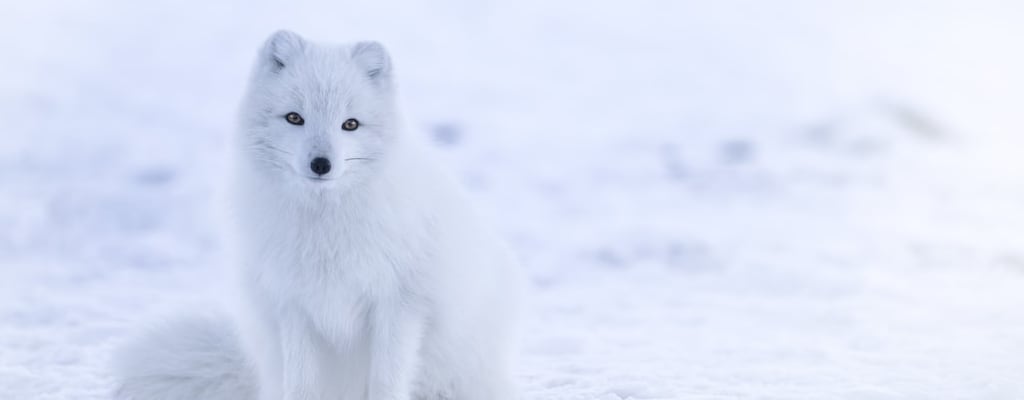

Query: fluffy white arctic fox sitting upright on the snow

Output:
[115, 31, 521, 400]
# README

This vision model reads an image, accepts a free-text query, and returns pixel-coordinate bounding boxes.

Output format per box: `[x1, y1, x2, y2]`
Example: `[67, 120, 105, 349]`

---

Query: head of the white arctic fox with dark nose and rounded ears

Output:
[240, 31, 396, 190]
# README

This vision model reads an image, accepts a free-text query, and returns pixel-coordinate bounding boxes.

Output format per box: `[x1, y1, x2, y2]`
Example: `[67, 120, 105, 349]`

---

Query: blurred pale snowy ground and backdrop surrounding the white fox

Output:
[0, 0, 1024, 400]
